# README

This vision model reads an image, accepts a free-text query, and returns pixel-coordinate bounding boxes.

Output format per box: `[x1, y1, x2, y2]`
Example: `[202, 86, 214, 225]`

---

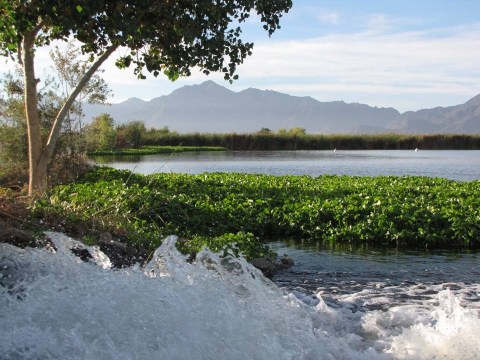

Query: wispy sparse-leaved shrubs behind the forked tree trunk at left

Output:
[0, 42, 110, 184]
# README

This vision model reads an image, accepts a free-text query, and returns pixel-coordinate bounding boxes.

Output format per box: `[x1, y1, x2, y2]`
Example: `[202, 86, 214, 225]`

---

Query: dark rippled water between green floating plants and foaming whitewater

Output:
[272, 243, 480, 311]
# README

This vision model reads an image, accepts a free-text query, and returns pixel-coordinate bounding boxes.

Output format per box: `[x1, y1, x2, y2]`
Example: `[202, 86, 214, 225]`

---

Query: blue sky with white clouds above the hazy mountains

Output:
[2, 0, 480, 112]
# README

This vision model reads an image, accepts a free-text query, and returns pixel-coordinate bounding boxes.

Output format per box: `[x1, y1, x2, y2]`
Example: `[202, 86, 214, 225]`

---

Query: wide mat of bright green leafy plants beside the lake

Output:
[37, 168, 480, 258]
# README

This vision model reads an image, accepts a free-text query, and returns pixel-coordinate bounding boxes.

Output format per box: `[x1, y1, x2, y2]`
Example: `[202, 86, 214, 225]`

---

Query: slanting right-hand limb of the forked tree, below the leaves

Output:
[44, 45, 118, 158]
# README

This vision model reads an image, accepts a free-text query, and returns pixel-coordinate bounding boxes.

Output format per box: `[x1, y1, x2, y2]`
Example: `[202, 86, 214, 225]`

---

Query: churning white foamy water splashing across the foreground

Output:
[0, 233, 480, 360]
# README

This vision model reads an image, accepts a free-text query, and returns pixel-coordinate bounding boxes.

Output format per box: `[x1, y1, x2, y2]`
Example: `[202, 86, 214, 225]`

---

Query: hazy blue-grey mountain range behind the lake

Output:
[85, 81, 480, 134]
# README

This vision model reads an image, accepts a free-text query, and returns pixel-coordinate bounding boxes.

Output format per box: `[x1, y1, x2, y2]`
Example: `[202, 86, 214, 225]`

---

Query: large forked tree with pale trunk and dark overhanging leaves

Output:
[0, 0, 292, 196]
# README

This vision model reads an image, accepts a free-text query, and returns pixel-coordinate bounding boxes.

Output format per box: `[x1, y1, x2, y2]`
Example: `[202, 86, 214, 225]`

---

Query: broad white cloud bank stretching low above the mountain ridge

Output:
[2, 21, 480, 110]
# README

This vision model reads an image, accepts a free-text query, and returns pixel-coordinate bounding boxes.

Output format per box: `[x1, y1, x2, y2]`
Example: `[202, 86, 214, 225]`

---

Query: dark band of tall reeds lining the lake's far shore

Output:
[144, 130, 480, 150]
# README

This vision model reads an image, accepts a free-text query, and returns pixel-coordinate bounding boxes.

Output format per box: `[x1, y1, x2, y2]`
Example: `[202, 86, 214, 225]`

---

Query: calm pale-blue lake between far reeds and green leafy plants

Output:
[92, 150, 480, 181]
